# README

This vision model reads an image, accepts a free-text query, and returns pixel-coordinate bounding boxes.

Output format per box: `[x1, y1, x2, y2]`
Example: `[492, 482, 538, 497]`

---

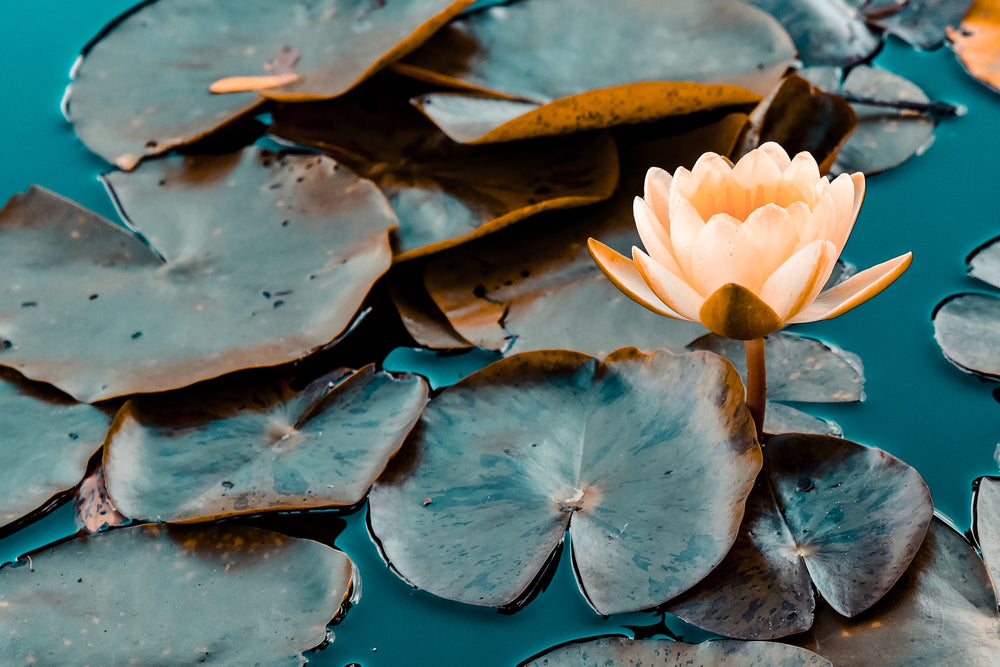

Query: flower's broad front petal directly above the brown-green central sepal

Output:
[690, 213, 765, 296]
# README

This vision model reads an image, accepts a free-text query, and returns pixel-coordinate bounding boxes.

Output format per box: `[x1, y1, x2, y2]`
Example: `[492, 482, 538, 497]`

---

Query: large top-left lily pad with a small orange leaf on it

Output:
[65, 0, 473, 169]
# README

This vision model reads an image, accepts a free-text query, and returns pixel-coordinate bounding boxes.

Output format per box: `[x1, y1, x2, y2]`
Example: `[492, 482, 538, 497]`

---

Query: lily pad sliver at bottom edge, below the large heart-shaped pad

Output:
[518, 637, 830, 667]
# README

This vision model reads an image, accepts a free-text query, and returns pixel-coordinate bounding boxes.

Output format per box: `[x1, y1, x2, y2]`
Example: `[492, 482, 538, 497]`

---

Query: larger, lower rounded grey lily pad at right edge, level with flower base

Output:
[931, 293, 1000, 379]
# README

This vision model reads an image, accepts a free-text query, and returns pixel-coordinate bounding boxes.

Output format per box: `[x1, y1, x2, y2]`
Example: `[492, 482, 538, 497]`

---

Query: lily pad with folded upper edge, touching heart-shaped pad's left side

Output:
[104, 366, 427, 521]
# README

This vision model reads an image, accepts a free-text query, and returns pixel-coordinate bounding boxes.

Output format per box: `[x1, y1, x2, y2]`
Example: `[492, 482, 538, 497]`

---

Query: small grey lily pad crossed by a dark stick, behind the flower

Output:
[800, 65, 935, 174]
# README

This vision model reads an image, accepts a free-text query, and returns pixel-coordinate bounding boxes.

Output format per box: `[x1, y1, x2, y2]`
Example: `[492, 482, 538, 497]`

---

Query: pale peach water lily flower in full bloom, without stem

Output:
[589, 143, 912, 341]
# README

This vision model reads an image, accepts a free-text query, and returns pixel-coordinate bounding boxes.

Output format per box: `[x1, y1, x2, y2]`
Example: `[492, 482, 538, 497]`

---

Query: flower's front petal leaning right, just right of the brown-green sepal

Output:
[759, 240, 837, 320]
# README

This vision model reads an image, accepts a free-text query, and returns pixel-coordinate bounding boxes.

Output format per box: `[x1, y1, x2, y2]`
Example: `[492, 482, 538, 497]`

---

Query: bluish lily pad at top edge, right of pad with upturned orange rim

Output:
[749, 0, 882, 67]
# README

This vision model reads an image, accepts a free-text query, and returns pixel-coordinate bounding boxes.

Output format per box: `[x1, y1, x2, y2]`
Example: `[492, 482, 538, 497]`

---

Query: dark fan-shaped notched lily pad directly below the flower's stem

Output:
[669, 434, 934, 640]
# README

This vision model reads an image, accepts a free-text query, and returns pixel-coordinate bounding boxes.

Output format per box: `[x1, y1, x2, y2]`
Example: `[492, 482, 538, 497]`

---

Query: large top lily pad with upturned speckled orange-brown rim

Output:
[395, 0, 794, 143]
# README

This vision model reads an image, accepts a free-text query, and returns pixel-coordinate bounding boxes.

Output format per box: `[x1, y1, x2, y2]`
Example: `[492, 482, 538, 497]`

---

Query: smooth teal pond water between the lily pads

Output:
[0, 0, 1000, 667]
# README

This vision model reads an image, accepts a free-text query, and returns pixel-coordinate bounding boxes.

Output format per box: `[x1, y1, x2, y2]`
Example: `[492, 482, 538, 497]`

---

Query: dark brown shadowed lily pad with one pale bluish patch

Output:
[272, 77, 618, 261]
